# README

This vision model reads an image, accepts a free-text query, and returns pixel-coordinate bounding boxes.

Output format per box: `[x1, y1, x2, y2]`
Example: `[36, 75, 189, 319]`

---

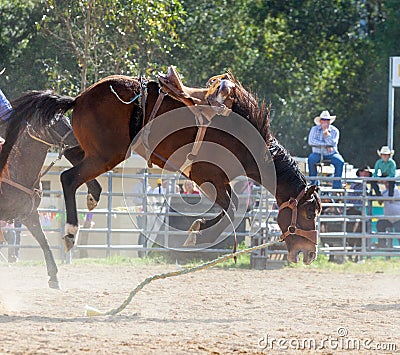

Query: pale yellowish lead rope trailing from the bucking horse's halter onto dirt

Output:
[85, 242, 275, 317]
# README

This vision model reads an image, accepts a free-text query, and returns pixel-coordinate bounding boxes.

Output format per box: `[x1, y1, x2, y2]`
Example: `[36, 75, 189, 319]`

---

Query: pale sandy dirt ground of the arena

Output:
[0, 264, 400, 354]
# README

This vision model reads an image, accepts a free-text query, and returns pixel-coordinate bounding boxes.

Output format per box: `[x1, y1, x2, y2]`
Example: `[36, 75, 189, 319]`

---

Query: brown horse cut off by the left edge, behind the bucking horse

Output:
[0, 96, 101, 289]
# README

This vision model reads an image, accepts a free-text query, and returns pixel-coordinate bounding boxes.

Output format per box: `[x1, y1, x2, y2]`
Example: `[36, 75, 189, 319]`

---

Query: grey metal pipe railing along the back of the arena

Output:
[3, 172, 400, 262]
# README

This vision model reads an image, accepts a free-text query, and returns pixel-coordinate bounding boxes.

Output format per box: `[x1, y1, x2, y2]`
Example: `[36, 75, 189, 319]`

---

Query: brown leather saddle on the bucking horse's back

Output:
[158, 65, 235, 121]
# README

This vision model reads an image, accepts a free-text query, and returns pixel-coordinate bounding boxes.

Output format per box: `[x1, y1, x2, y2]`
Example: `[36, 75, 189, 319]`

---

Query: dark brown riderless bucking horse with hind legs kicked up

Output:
[0, 69, 321, 264]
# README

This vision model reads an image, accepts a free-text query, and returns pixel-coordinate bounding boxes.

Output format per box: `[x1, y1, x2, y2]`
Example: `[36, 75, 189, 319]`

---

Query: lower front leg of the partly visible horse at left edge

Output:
[23, 211, 60, 289]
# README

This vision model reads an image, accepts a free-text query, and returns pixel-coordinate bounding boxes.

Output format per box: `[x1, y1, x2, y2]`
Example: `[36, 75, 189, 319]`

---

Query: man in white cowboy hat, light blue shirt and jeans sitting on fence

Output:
[308, 111, 344, 189]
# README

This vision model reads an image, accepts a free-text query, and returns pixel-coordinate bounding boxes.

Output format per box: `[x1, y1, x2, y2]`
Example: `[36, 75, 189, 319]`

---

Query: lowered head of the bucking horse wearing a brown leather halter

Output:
[278, 185, 321, 265]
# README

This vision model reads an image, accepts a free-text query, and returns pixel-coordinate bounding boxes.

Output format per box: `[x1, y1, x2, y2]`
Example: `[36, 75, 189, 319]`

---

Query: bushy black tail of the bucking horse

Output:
[0, 90, 75, 176]
